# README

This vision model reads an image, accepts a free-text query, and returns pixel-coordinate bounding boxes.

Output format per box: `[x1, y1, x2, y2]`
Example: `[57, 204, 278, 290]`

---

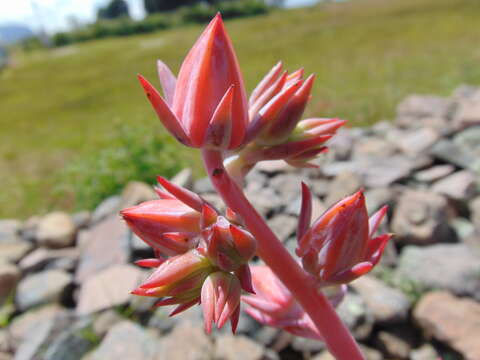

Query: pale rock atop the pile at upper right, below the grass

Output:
[395, 95, 453, 123]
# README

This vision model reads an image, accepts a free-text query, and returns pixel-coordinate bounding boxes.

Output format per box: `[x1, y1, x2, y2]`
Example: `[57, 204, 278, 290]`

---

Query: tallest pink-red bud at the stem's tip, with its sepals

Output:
[139, 14, 248, 149]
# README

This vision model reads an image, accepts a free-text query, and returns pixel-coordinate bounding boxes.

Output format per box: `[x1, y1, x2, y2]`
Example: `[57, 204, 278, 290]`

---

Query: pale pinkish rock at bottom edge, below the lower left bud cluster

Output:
[90, 321, 158, 360]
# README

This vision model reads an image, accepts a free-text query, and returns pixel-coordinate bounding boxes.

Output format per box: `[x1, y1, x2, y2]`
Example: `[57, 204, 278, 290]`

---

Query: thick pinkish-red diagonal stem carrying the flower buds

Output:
[202, 150, 365, 360]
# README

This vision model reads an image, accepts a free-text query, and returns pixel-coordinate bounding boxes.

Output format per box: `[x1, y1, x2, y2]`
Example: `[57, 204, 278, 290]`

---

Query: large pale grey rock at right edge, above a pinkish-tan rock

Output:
[395, 244, 480, 300]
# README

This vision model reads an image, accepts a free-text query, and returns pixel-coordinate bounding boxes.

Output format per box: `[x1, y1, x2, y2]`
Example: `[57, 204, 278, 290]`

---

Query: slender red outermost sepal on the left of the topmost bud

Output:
[138, 75, 190, 146]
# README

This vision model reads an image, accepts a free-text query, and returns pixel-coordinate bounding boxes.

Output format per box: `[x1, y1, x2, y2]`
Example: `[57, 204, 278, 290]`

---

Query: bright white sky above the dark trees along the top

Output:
[0, 0, 316, 33]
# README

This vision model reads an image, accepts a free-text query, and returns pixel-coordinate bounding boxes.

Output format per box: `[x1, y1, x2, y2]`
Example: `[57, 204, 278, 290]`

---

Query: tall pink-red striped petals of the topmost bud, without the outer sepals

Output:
[172, 14, 248, 148]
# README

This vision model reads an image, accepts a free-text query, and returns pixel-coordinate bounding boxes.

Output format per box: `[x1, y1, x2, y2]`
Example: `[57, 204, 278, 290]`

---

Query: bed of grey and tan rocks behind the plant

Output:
[0, 86, 480, 360]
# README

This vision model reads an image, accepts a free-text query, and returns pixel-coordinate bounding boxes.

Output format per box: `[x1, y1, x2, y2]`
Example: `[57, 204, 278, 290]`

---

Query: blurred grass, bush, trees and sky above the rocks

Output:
[0, 0, 480, 218]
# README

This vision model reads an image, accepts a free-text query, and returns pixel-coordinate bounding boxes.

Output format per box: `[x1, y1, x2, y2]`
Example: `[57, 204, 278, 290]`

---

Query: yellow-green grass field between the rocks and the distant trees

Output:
[0, 0, 480, 218]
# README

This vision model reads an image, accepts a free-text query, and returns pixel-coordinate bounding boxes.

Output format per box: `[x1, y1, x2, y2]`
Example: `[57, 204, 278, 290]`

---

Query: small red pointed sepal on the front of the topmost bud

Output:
[203, 85, 235, 149]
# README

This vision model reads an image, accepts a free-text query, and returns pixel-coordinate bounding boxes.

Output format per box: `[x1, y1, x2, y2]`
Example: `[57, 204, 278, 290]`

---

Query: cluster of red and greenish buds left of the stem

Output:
[121, 178, 256, 332]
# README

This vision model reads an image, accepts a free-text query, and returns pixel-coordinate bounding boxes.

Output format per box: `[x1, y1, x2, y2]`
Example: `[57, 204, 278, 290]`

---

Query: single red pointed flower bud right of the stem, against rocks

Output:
[296, 184, 392, 285]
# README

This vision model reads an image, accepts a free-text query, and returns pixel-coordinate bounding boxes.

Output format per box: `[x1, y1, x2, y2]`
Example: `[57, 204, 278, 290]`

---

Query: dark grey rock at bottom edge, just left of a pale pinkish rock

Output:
[44, 320, 94, 360]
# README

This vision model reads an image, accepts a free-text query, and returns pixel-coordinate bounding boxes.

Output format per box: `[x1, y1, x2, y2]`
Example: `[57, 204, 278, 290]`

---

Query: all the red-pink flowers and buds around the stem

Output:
[126, 15, 391, 346]
